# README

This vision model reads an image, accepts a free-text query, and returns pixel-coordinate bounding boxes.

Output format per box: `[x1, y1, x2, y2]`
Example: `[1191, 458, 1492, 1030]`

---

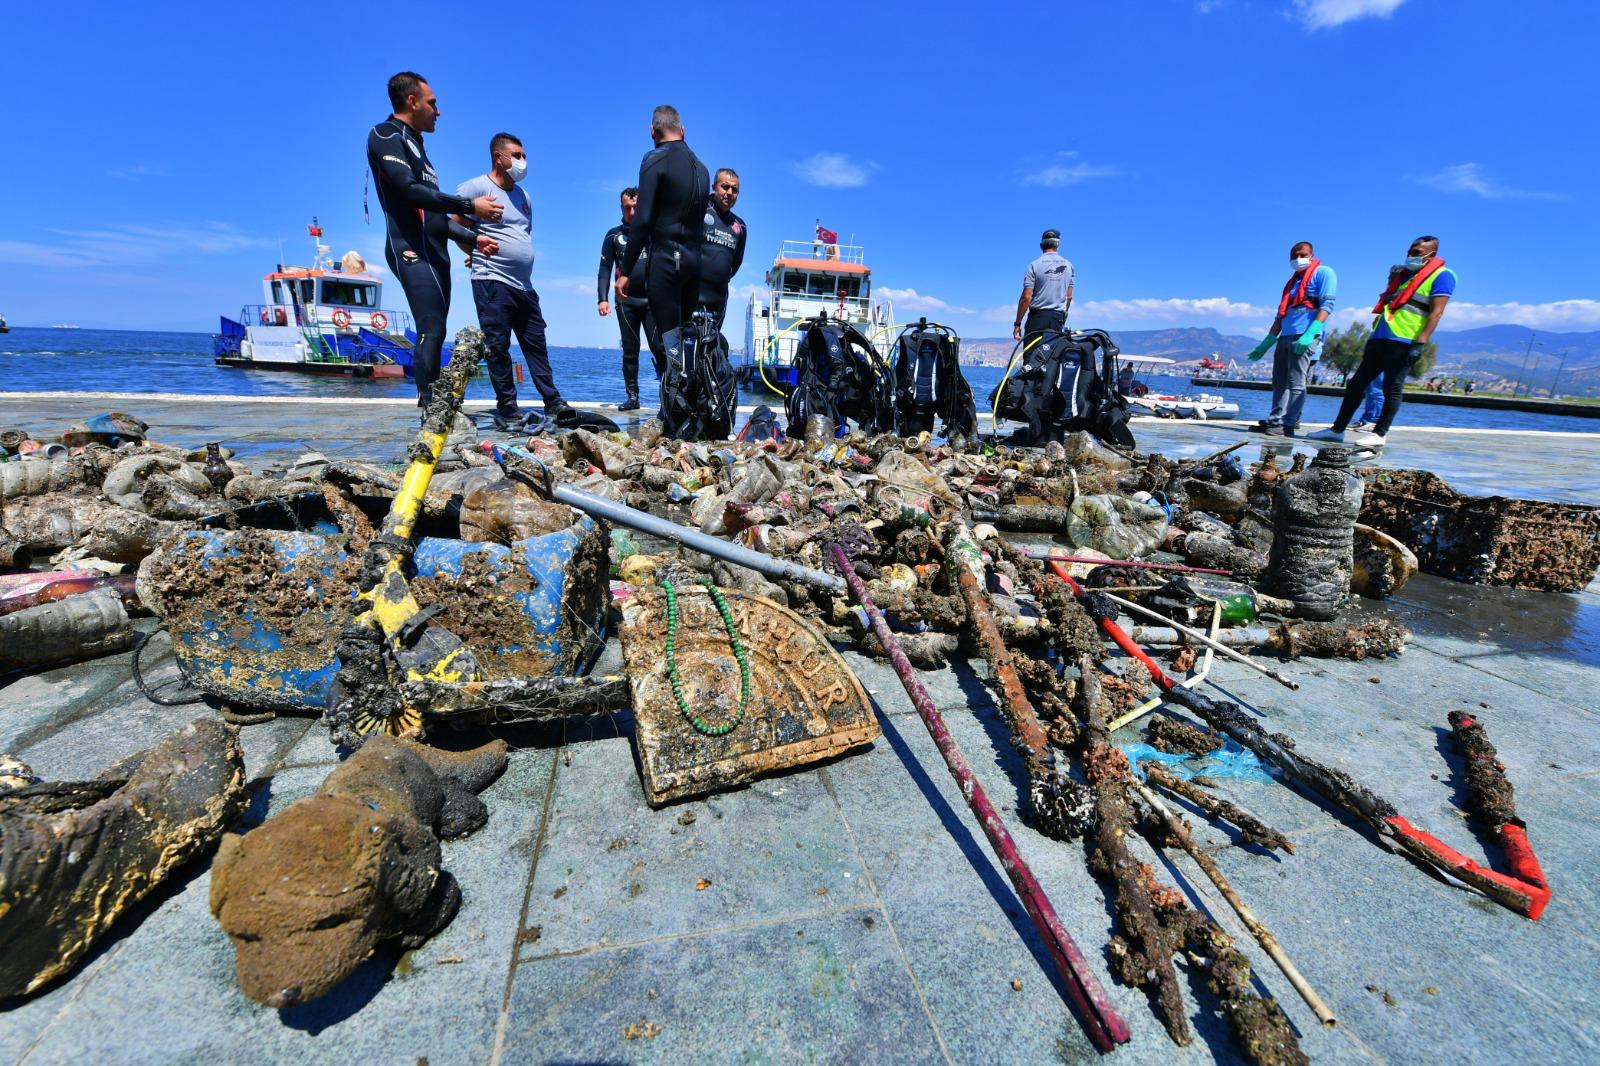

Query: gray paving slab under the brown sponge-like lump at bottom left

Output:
[12, 751, 554, 1064]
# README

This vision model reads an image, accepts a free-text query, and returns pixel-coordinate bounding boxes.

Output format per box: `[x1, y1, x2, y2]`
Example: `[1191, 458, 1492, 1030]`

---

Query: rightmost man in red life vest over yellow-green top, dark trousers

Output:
[1310, 237, 1456, 448]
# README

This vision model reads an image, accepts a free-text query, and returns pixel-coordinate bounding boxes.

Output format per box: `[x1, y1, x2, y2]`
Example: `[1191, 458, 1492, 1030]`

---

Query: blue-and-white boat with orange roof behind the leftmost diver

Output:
[211, 218, 416, 378]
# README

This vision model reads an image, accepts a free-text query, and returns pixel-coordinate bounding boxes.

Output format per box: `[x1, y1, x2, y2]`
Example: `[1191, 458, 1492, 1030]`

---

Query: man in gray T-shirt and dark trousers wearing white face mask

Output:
[456, 133, 574, 421]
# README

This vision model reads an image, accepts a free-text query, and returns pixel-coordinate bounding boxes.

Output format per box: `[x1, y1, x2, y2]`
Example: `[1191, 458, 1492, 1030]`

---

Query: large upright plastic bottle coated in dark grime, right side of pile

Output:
[1267, 448, 1365, 621]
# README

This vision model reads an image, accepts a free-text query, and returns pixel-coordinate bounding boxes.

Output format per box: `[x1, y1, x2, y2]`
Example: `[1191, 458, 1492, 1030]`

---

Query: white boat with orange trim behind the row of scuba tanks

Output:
[734, 226, 894, 395]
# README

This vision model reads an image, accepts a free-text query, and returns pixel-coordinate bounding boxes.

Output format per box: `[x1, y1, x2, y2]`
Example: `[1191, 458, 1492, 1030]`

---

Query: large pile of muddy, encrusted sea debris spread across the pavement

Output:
[0, 372, 1561, 1063]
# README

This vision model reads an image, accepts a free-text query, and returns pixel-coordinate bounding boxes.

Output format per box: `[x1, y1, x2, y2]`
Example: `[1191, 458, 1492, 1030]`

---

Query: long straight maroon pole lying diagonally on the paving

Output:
[827, 544, 1130, 1052]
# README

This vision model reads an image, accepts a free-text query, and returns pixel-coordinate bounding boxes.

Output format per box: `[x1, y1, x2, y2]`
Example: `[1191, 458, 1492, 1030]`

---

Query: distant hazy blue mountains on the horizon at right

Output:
[962, 325, 1600, 395]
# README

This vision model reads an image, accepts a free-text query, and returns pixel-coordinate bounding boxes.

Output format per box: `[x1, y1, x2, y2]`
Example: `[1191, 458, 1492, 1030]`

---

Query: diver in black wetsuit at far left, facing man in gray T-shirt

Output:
[366, 70, 504, 408]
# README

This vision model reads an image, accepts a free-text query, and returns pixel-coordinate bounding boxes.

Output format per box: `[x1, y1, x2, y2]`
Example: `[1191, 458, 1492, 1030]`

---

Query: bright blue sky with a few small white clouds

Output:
[0, 0, 1600, 346]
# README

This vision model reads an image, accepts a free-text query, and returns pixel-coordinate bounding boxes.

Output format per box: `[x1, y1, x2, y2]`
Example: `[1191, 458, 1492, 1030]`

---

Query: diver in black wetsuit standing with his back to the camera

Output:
[616, 104, 710, 342]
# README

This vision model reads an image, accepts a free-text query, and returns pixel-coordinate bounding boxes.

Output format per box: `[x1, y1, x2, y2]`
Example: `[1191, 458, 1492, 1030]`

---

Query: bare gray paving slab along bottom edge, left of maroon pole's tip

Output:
[499, 908, 941, 1063]
